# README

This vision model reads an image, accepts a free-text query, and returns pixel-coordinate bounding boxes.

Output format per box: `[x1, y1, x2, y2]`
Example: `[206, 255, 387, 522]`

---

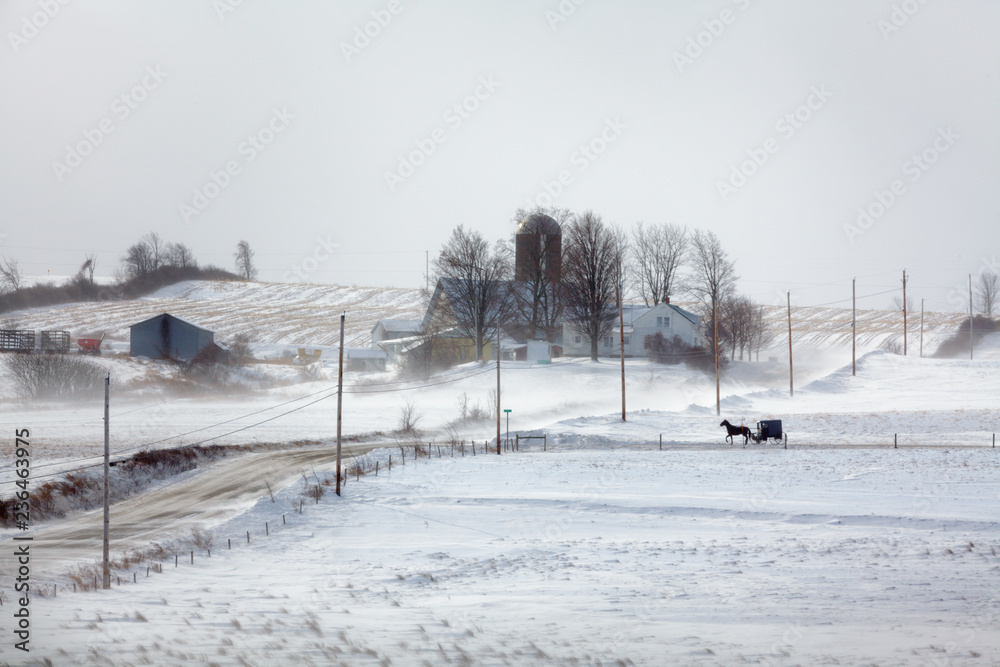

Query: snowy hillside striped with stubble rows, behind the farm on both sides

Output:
[4, 281, 964, 359]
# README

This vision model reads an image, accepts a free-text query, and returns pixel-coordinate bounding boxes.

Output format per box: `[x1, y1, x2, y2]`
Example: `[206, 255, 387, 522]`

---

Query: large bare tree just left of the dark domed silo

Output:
[434, 225, 512, 359]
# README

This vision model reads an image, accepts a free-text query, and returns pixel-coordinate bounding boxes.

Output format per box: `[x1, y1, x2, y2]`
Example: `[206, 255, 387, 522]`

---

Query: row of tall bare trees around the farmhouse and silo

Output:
[433, 208, 771, 360]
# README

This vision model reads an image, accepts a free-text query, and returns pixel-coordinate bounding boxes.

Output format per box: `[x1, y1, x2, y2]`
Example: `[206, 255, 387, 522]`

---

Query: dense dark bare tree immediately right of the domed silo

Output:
[562, 211, 624, 361]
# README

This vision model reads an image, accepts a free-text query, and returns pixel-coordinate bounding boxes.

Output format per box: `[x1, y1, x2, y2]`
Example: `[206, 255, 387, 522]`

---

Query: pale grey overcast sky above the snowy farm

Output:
[0, 0, 1000, 310]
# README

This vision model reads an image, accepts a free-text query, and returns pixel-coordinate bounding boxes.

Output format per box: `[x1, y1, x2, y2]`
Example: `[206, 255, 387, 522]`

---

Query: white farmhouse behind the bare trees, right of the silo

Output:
[563, 303, 705, 357]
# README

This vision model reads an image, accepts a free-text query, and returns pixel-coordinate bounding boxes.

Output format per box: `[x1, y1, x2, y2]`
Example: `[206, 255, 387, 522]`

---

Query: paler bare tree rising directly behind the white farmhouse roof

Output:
[632, 222, 689, 306]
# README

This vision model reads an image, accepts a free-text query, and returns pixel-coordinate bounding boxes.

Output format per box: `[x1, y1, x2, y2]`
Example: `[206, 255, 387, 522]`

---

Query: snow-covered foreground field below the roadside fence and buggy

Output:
[15, 448, 1000, 665]
